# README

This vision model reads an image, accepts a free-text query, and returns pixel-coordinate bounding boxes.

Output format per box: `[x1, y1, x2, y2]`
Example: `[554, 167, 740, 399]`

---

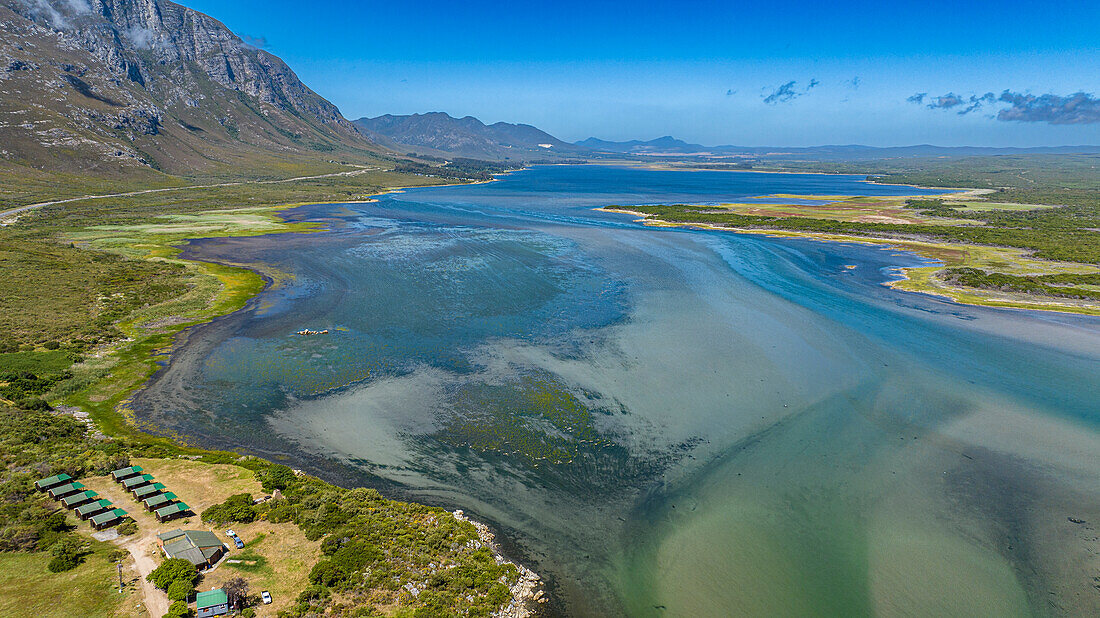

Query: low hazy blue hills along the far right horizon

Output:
[576, 135, 1100, 161]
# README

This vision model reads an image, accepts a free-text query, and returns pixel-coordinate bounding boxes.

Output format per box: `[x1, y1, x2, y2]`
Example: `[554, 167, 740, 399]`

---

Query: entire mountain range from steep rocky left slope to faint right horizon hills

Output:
[0, 0, 1100, 176]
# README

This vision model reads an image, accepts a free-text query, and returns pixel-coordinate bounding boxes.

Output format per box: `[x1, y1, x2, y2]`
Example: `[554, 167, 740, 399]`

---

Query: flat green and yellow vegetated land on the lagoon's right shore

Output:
[602, 155, 1100, 314]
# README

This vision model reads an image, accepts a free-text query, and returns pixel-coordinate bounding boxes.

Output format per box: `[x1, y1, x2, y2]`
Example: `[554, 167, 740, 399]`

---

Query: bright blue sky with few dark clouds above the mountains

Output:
[184, 0, 1100, 146]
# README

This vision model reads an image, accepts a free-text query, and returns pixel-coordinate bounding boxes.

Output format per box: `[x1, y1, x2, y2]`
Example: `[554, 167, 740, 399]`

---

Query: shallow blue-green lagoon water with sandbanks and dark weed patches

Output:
[133, 166, 1100, 616]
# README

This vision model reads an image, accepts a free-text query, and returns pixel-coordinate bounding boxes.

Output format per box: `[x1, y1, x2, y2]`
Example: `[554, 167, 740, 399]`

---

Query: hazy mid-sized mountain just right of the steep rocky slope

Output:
[354, 112, 587, 161]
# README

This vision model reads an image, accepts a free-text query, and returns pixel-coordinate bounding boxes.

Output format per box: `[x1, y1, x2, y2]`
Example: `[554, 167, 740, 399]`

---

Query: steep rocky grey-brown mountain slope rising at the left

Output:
[0, 0, 381, 174]
